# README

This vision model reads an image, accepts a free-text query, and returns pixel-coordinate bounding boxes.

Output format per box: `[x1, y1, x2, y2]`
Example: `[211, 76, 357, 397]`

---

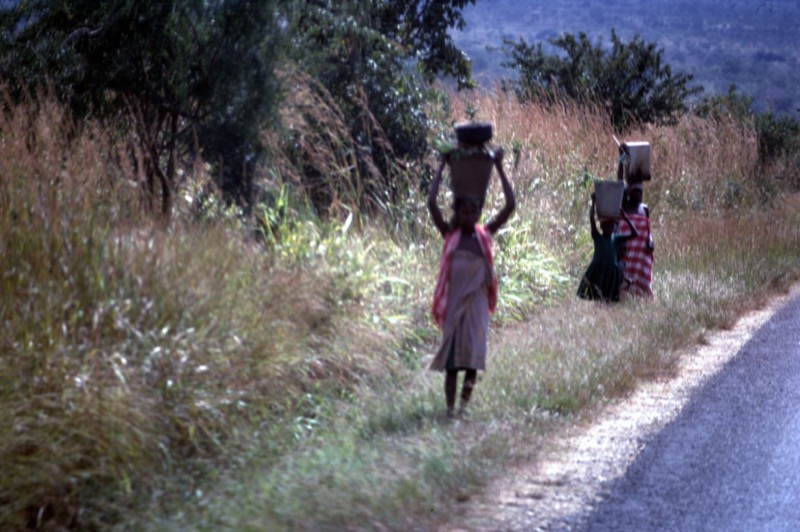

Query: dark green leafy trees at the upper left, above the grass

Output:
[0, 0, 474, 217]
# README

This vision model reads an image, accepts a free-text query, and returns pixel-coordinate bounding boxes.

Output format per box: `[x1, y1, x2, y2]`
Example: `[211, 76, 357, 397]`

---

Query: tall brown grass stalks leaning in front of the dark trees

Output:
[262, 66, 410, 217]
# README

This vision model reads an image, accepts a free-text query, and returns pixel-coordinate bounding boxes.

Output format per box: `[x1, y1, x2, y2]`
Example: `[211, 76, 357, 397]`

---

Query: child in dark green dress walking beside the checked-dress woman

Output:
[578, 194, 639, 301]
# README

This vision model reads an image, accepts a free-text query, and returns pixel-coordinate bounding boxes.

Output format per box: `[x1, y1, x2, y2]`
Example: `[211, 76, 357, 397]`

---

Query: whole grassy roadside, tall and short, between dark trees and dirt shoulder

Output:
[0, 90, 800, 530]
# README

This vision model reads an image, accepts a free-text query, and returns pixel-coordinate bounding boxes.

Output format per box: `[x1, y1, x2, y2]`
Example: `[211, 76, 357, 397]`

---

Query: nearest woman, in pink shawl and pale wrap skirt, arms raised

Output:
[428, 148, 516, 418]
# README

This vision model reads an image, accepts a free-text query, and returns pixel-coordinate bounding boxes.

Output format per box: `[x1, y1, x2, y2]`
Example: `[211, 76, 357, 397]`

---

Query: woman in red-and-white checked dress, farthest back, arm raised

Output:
[617, 143, 655, 297]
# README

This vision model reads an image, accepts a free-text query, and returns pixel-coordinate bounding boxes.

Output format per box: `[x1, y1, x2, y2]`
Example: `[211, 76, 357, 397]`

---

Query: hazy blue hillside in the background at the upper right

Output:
[454, 0, 800, 116]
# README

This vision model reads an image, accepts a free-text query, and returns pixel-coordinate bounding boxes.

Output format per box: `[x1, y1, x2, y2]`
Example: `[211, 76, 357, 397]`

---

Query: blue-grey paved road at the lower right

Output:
[575, 297, 800, 531]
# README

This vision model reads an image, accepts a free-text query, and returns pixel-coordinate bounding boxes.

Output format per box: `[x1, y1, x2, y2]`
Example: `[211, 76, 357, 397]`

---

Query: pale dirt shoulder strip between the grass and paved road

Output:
[441, 284, 800, 532]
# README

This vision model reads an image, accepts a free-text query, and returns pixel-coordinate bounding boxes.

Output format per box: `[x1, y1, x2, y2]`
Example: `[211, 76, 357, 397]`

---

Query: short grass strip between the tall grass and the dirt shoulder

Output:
[156, 197, 800, 530]
